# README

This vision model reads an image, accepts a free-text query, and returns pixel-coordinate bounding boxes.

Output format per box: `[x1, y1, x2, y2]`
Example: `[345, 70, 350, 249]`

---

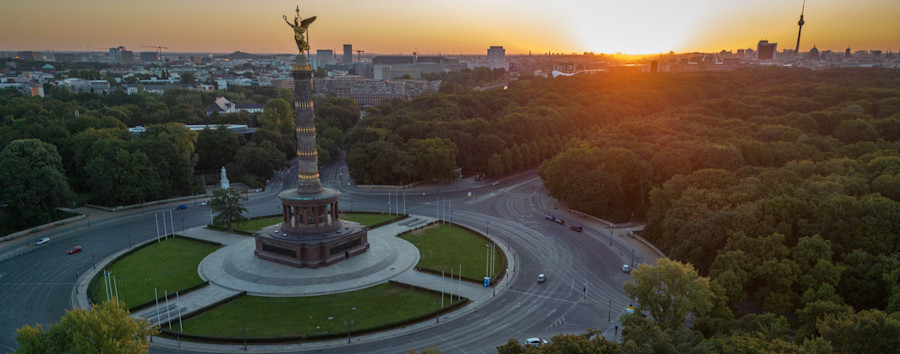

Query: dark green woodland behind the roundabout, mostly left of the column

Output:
[0, 85, 360, 230]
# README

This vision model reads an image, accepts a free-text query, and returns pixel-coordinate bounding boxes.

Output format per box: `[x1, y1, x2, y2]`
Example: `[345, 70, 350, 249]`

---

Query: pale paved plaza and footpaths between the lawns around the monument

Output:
[72, 216, 516, 353]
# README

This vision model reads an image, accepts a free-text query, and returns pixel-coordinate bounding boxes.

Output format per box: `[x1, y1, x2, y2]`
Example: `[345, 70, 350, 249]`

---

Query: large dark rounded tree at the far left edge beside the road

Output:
[0, 139, 74, 228]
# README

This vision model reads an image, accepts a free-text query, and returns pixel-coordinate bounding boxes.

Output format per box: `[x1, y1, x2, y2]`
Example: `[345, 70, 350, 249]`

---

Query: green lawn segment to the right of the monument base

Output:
[401, 224, 506, 281]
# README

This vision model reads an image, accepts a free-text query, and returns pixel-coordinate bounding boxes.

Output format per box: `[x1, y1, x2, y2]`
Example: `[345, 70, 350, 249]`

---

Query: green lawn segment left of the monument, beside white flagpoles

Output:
[88, 237, 221, 308]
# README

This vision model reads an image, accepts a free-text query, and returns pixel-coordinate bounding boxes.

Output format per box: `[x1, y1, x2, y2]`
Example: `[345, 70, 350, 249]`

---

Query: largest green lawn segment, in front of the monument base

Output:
[180, 283, 458, 338]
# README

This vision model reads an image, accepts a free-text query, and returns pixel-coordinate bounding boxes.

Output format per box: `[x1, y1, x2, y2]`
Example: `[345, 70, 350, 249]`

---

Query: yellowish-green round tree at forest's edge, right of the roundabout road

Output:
[622, 258, 713, 331]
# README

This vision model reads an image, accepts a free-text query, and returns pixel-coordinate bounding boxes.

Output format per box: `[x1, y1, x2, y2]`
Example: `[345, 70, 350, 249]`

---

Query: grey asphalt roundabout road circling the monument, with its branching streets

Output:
[0, 156, 631, 353]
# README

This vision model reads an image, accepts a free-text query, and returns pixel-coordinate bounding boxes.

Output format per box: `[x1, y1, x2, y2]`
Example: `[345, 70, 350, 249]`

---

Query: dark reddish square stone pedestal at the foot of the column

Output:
[253, 221, 369, 268]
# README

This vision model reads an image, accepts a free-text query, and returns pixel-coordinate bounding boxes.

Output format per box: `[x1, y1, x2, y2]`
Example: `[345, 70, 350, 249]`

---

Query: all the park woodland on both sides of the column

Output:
[0, 68, 900, 352]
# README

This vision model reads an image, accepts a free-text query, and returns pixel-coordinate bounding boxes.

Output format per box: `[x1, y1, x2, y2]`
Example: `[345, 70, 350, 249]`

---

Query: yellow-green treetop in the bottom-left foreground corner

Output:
[16, 301, 159, 353]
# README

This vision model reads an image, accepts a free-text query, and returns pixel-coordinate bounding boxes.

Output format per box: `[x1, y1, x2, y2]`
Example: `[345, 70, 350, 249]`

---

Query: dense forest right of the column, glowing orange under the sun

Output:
[345, 68, 900, 345]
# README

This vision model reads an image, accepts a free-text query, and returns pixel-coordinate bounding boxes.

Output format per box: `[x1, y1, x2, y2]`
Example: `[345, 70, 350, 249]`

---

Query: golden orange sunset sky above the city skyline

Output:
[0, 0, 900, 54]
